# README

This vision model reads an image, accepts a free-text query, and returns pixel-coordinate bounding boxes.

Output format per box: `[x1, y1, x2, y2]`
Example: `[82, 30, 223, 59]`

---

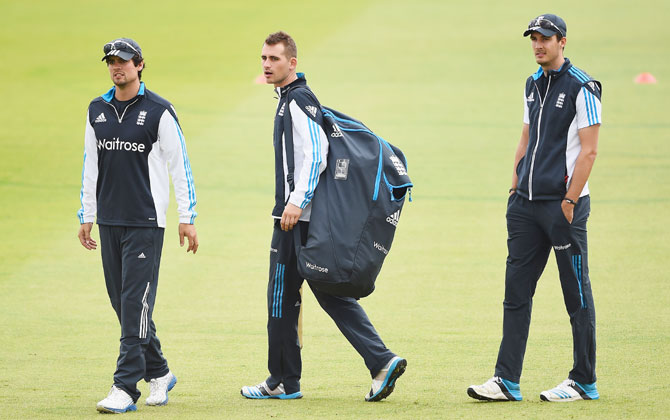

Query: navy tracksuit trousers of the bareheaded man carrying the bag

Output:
[266, 220, 395, 394]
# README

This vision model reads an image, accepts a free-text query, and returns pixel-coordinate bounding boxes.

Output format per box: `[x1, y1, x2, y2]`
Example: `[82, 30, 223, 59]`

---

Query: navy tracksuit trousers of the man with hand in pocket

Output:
[495, 194, 596, 384]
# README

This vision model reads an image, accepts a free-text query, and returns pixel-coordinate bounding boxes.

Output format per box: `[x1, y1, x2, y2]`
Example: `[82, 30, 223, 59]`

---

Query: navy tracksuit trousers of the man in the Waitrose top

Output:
[99, 225, 169, 401]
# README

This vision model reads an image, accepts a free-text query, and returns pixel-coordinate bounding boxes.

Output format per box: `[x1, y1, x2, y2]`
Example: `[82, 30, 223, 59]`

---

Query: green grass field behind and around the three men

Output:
[0, 0, 670, 419]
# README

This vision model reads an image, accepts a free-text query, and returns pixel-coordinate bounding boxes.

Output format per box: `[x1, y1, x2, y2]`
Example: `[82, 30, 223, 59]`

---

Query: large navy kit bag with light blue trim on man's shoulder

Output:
[287, 88, 413, 298]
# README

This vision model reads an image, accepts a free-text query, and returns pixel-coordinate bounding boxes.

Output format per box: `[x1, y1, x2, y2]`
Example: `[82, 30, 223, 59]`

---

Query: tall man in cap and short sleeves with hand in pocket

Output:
[467, 14, 601, 401]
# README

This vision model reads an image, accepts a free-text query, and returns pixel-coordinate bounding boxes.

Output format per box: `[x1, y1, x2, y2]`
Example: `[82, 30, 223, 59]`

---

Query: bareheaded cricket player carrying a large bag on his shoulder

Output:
[241, 32, 407, 401]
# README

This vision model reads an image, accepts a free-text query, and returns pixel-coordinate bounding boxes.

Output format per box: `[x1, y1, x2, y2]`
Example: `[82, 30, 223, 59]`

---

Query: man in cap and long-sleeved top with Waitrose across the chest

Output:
[77, 38, 198, 413]
